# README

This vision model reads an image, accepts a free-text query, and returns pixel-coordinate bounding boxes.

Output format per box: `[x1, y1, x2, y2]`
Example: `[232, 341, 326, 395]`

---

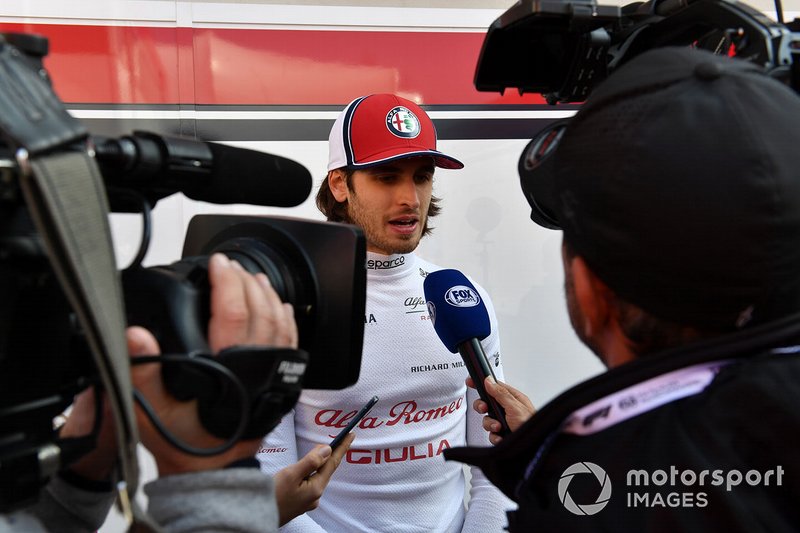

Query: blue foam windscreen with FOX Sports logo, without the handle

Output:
[423, 269, 492, 353]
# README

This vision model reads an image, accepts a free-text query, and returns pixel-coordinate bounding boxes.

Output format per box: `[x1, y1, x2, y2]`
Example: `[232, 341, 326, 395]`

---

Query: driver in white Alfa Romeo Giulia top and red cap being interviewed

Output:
[258, 94, 513, 533]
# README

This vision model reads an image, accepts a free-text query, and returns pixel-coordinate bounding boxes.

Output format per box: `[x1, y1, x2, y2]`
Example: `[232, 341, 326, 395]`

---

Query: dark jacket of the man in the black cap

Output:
[445, 317, 800, 533]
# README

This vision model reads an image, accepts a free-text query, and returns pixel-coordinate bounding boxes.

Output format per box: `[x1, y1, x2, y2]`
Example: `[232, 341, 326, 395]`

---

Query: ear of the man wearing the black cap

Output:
[569, 255, 616, 337]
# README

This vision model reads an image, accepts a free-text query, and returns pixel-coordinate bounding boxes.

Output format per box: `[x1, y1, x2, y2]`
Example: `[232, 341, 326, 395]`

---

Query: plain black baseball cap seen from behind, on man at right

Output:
[520, 47, 800, 330]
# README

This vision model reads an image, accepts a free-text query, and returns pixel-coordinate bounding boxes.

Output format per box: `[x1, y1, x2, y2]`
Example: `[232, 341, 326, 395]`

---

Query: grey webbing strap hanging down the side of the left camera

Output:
[17, 149, 148, 522]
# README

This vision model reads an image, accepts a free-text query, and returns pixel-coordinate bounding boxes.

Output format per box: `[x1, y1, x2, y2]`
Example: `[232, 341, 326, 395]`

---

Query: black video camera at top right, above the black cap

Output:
[475, 0, 800, 229]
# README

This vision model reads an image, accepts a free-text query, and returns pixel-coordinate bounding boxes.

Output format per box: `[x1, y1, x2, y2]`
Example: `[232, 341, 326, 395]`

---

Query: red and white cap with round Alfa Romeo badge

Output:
[328, 94, 464, 170]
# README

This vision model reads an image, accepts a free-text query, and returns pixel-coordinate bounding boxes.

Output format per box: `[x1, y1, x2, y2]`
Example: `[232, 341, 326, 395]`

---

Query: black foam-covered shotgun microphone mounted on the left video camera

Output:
[92, 131, 312, 212]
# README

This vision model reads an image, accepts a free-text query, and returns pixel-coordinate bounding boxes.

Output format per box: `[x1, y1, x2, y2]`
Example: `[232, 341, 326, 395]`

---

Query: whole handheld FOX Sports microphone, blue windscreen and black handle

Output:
[423, 269, 511, 435]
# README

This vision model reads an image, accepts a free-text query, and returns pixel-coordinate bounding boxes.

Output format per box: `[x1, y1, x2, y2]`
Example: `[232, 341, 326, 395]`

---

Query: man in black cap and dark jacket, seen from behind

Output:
[446, 47, 800, 532]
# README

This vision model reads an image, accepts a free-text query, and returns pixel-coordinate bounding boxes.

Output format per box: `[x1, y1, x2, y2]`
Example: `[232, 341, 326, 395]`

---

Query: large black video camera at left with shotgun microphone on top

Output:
[0, 34, 366, 512]
